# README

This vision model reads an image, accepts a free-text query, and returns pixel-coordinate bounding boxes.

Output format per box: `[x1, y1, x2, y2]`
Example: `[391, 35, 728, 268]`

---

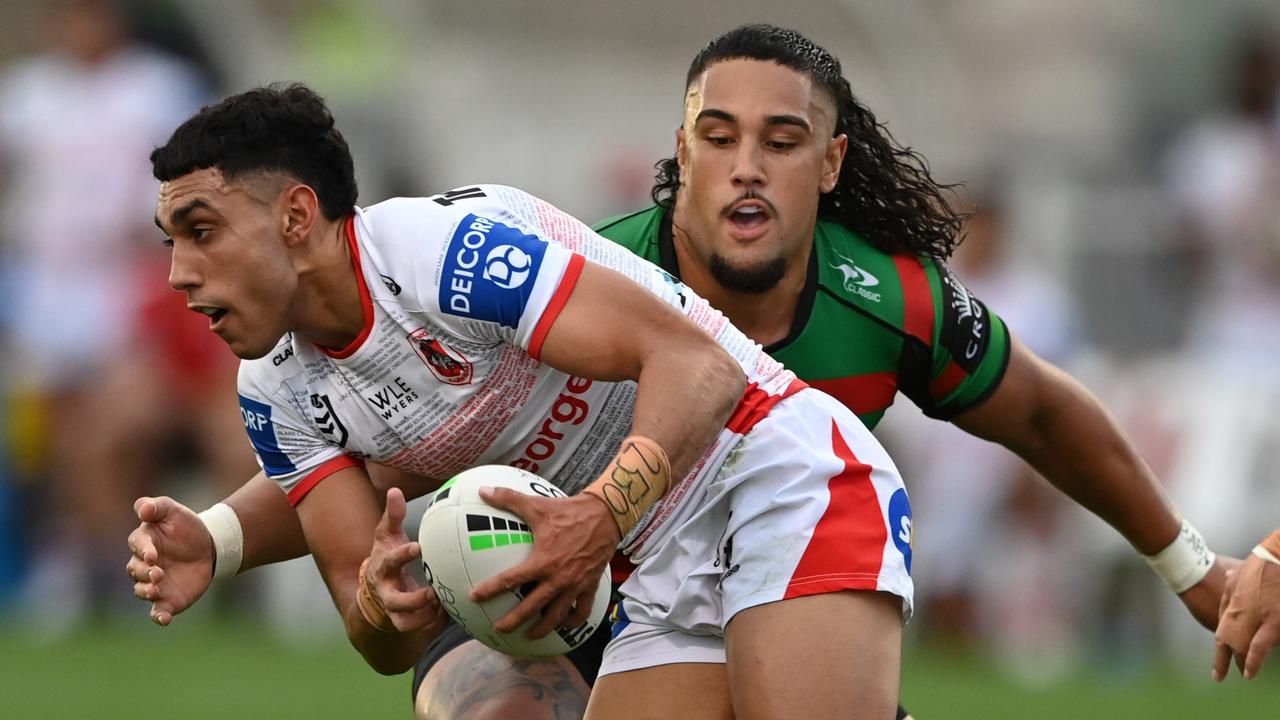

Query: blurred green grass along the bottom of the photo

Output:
[0, 618, 1280, 720]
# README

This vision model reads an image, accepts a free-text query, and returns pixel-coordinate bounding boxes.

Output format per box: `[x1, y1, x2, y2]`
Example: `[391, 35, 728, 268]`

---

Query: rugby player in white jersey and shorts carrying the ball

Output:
[129, 86, 911, 719]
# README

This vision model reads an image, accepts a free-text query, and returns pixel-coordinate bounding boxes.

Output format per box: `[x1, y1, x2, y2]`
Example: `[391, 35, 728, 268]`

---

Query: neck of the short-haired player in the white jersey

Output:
[292, 218, 365, 350]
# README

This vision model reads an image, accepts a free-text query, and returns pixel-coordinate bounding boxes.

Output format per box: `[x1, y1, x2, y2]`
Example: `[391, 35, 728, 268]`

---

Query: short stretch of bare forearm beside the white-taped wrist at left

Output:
[223, 471, 310, 573]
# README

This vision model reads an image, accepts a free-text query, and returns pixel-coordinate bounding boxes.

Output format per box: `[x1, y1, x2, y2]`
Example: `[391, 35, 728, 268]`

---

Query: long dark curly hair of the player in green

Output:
[652, 24, 964, 259]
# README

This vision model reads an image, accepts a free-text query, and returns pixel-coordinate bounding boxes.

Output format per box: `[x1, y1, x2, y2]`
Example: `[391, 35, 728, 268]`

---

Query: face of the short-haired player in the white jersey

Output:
[156, 169, 298, 359]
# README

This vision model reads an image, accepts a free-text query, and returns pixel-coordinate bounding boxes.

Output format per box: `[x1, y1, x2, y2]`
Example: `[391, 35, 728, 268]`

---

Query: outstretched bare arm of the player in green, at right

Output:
[954, 336, 1225, 628]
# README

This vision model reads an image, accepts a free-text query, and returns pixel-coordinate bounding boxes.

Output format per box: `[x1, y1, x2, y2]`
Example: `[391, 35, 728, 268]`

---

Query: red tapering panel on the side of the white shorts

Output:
[782, 420, 888, 600]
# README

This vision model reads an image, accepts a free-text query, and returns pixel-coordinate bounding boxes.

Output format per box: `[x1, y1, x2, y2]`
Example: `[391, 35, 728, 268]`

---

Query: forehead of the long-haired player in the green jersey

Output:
[685, 59, 833, 120]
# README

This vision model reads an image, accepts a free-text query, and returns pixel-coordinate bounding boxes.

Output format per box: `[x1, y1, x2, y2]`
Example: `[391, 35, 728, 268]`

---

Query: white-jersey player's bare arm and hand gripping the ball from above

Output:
[471, 263, 746, 637]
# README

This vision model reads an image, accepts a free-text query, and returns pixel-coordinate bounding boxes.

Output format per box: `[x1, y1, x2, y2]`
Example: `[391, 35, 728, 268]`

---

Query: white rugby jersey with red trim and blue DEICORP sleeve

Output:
[239, 184, 803, 548]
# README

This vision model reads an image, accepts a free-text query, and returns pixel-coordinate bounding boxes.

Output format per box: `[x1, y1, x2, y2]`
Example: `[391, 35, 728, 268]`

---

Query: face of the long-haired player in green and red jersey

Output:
[675, 59, 846, 292]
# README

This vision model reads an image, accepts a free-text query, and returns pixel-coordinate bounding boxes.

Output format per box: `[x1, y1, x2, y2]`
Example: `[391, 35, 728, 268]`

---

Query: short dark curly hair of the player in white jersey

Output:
[151, 83, 357, 220]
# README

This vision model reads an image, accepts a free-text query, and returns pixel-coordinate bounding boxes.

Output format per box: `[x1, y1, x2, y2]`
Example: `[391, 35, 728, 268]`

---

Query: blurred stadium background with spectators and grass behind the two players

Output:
[0, 0, 1280, 720]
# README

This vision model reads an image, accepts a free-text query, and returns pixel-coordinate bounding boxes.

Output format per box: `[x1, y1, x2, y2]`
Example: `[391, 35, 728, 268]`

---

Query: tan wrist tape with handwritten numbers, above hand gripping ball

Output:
[582, 436, 671, 537]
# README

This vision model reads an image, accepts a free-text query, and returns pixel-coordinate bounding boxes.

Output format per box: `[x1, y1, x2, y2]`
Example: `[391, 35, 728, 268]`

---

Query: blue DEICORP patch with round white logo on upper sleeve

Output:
[440, 215, 547, 329]
